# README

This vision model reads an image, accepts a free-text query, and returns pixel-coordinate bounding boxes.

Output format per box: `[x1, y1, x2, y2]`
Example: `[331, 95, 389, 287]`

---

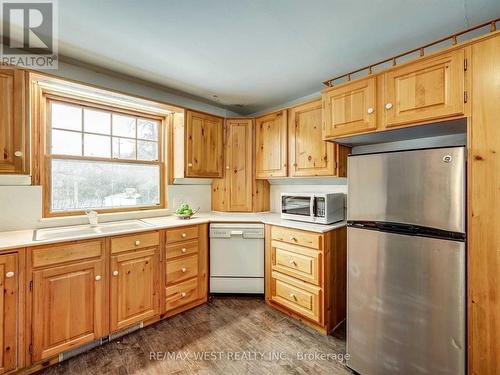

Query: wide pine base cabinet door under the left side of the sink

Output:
[32, 259, 107, 362]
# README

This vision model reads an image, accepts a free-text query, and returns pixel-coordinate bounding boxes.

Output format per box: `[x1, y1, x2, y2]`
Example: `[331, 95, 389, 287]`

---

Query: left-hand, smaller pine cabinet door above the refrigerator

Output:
[322, 77, 377, 139]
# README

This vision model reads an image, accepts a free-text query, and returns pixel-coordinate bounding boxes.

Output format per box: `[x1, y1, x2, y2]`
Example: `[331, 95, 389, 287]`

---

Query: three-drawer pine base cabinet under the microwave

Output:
[265, 225, 347, 333]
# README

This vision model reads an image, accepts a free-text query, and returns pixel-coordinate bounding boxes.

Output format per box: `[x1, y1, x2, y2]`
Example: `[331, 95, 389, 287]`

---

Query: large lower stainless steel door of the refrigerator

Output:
[347, 227, 465, 375]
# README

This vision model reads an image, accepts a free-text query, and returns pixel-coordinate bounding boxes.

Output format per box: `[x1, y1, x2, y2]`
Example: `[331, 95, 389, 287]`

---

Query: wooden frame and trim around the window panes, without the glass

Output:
[35, 87, 171, 218]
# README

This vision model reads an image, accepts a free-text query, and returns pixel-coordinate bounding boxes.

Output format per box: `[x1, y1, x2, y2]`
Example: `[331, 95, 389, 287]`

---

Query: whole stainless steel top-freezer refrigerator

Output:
[347, 147, 466, 375]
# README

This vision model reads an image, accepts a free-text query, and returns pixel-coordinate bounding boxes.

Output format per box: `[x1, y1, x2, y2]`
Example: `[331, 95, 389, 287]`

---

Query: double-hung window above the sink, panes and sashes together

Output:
[44, 97, 164, 216]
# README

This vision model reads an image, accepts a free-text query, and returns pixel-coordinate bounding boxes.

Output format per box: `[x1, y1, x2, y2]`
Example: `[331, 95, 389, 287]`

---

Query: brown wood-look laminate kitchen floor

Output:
[37, 297, 350, 375]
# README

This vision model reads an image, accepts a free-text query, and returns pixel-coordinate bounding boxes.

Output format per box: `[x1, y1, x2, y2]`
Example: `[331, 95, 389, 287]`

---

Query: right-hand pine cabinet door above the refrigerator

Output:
[381, 49, 465, 128]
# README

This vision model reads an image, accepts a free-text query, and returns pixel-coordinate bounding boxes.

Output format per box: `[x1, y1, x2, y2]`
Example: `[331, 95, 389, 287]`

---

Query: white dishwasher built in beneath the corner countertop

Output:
[210, 223, 264, 294]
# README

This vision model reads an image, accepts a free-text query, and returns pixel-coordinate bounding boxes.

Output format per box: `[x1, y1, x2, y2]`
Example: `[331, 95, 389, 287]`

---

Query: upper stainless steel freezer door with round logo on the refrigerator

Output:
[347, 147, 466, 233]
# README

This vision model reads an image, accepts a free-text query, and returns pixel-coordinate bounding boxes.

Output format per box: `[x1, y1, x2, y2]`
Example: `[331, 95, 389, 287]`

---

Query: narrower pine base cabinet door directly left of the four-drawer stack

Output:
[110, 248, 161, 331]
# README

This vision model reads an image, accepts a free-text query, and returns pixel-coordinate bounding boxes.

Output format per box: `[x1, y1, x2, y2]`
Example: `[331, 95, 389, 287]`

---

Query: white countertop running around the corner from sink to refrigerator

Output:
[0, 212, 346, 251]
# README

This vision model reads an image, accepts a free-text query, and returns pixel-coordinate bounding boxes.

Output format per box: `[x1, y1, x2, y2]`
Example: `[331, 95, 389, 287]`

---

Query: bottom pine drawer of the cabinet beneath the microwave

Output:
[271, 271, 322, 323]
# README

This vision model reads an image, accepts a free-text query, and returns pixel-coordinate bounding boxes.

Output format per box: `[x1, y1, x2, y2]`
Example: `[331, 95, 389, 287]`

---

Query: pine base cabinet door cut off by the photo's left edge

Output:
[0, 254, 19, 374]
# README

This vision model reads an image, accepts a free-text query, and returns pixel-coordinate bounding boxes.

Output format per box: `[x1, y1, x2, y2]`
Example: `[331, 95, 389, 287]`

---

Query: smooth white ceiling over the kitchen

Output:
[58, 0, 500, 114]
